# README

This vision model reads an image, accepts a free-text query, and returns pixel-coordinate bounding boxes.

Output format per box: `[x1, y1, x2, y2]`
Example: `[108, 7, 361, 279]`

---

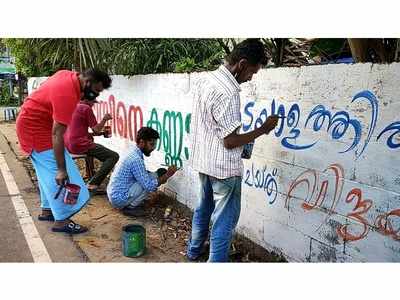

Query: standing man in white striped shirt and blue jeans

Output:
[187, 39, 278, 262]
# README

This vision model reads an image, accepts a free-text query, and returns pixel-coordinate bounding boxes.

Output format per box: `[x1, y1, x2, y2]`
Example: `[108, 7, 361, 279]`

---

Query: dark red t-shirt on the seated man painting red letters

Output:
[64, 103, 97, 154]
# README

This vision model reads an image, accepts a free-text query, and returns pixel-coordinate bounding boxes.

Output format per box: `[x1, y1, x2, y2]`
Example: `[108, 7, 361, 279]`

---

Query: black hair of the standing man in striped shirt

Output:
[226, 39, 268, 65]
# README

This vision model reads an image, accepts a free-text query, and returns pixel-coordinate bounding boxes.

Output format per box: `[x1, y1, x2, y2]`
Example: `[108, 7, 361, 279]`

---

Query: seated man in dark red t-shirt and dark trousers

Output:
[64, 100, 119, 194]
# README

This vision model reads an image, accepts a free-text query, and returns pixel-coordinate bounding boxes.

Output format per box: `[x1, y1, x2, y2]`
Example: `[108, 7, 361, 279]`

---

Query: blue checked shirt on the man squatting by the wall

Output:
[107, 146, 158, 202]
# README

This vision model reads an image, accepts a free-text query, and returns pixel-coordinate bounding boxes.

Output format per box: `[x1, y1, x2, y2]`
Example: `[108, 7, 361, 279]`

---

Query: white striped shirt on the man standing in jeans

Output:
[190, 66, 243, 179]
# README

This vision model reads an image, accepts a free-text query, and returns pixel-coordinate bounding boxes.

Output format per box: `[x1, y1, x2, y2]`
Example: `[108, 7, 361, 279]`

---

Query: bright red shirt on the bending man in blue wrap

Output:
[16, 70, 81, 154]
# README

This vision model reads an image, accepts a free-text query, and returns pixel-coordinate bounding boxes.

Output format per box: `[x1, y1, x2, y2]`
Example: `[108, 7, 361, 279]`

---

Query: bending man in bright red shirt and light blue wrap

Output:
[16, 69, 111, 234]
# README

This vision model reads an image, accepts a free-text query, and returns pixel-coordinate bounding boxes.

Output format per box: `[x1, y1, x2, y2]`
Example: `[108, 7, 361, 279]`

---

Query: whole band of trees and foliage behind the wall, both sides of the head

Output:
[7, 38, 399, 77]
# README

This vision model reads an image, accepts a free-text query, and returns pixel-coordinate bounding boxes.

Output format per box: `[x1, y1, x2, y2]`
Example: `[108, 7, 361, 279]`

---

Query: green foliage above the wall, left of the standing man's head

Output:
[4, 39, 224, 77]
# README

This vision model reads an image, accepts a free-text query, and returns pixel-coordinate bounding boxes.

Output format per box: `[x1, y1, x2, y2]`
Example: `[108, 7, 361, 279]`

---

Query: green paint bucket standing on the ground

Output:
[122, 224, 146, 257]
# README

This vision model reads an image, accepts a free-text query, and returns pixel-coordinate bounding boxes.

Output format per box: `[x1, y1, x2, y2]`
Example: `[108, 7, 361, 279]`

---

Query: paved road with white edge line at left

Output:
[0, 123, 87, 262]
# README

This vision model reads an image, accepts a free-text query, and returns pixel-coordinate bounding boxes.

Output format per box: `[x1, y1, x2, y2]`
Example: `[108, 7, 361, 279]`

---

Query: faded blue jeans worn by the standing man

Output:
[187, 173, 242, 262]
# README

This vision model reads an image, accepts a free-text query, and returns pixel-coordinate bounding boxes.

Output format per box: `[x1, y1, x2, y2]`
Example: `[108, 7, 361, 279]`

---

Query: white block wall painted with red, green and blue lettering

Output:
[29, 63, 400, 262]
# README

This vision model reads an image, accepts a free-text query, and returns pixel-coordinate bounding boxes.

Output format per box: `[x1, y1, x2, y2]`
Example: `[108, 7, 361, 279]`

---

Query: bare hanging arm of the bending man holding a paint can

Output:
[52, 121, 68, 185]
